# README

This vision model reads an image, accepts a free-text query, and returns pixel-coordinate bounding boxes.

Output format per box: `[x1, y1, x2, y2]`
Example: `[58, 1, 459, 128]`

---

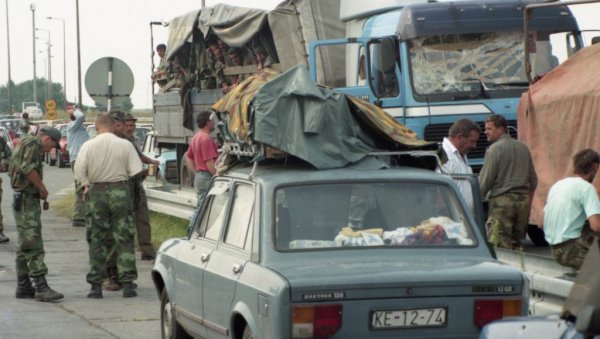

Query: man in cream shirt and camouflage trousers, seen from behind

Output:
[75, 113, 142, 298]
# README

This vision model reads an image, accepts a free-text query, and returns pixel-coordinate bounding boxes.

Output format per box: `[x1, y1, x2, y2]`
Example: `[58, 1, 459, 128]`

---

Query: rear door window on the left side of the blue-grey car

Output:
[225, 185, 254, 249]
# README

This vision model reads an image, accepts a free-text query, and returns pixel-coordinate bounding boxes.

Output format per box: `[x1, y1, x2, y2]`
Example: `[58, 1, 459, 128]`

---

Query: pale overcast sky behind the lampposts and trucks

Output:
[0, 0, 600, 109]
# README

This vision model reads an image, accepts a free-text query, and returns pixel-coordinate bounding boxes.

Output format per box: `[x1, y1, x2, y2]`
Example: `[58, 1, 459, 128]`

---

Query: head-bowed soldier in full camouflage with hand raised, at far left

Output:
[8, 127, 63, 301]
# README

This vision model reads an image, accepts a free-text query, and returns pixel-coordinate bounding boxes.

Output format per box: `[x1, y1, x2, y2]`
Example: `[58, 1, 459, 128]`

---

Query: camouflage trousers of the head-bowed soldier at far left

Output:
[13, 193, 48, 277]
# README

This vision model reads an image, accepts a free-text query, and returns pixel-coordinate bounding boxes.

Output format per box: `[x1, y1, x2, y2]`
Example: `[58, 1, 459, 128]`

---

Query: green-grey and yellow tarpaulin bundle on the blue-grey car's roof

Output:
[213, 65, 438, 169]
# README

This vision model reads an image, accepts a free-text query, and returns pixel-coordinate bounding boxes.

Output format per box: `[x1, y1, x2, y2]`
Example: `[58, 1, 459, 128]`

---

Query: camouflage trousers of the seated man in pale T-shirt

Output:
[550, 221, 596, 270]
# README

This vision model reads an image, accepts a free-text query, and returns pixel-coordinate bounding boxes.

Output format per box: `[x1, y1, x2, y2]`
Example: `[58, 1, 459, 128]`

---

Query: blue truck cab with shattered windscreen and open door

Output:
[309, 0, 583, 171]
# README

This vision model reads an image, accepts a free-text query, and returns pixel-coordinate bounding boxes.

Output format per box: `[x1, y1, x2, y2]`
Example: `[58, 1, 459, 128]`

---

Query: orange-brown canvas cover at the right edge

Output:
[517, 44, 600, 225]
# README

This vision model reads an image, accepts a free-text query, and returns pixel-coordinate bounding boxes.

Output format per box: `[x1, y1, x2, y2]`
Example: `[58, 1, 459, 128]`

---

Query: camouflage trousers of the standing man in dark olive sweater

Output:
[486, 193, 529, 250]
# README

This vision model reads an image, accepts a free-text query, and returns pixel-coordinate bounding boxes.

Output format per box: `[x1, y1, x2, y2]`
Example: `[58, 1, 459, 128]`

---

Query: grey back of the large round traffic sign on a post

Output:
[85, 57, 133, 106]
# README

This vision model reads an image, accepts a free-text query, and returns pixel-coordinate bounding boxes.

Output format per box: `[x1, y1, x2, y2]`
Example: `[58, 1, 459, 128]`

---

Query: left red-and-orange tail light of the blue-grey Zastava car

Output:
[292, 304, 342, 338]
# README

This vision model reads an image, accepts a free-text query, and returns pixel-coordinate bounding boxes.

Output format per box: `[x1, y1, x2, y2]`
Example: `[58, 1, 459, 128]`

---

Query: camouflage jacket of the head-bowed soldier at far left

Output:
[8, 135, 44, 194]
